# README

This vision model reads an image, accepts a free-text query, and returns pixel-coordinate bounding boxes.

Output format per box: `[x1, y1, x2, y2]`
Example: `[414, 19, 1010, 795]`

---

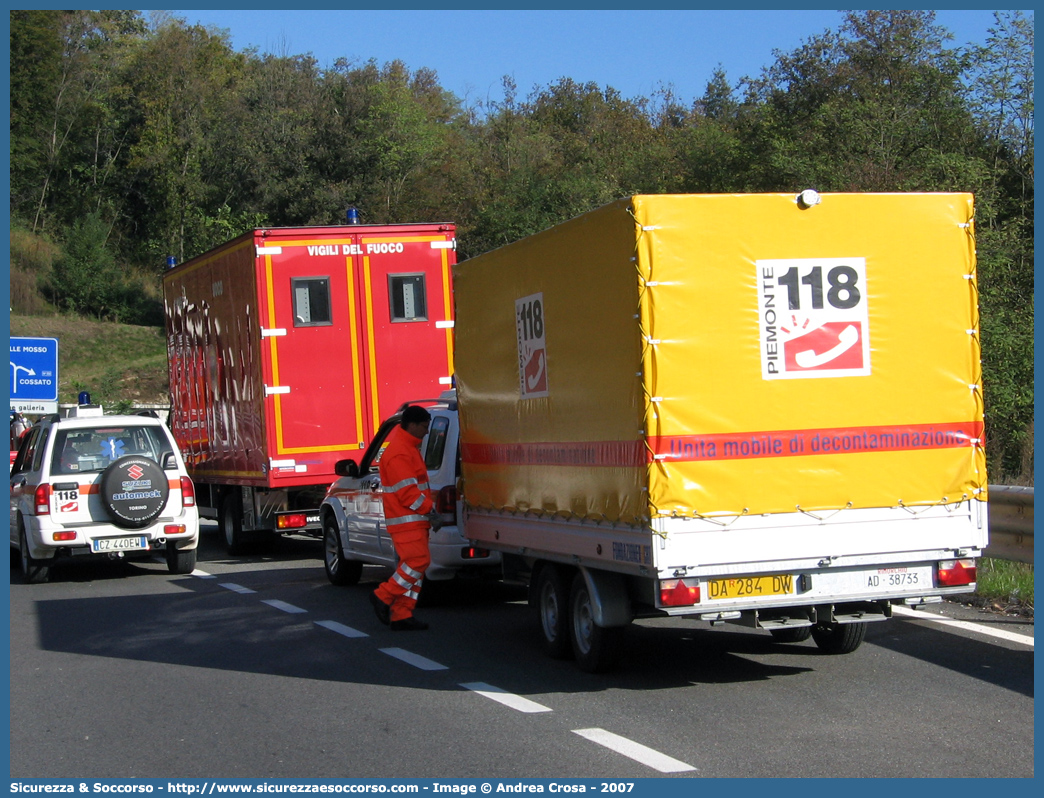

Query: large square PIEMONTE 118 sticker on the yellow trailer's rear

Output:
[755, 258, 870, 379]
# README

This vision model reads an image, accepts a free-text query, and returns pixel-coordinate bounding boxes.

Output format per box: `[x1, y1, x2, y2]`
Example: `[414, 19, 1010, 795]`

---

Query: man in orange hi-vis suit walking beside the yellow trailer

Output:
[370, 405, 437, 631]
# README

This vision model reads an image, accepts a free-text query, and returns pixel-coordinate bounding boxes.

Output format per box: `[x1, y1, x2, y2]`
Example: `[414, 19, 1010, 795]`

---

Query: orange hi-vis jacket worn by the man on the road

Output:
[377, 426, 435, 535]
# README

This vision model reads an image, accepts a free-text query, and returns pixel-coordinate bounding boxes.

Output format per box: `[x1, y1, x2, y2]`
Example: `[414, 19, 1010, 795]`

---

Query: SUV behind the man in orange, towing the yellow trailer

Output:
[319, 391, 500, 585]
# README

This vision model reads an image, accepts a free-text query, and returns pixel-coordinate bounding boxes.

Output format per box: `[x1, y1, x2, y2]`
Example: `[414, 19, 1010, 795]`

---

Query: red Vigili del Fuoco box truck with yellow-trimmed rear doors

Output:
[163, 224, 456, 553]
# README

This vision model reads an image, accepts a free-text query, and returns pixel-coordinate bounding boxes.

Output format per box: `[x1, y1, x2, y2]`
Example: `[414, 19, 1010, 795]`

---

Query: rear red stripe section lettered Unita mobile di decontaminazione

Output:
[649, 421, 982, 462]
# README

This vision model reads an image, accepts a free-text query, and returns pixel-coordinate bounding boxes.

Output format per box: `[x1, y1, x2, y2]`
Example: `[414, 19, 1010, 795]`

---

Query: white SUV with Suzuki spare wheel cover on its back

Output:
[10, 407, 199, 583]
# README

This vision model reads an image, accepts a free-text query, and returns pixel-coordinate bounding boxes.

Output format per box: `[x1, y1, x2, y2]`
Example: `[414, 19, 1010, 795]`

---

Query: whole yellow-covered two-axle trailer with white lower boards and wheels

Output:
[454, 191, 987, 667]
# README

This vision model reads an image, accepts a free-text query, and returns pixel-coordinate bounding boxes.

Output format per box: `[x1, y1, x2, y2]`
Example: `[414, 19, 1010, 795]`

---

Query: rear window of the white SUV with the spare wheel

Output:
[51, 426, 171, 474]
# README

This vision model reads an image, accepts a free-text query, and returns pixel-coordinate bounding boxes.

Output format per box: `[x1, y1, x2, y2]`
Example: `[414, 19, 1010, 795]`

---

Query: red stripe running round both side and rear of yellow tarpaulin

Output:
[460, 421, 982, 468]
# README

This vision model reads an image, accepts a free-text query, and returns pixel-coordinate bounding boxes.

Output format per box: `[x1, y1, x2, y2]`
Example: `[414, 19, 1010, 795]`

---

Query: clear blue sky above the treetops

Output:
[164, 8, 1010, 102]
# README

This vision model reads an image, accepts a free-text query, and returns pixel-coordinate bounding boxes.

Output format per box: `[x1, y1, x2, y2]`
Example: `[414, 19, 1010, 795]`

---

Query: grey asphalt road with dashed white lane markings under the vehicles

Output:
[10, 524, 1034, 779]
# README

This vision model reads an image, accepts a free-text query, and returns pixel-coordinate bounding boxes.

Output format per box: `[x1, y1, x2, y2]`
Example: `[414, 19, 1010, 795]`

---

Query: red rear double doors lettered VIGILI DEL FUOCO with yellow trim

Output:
[256, 226, 454, 476]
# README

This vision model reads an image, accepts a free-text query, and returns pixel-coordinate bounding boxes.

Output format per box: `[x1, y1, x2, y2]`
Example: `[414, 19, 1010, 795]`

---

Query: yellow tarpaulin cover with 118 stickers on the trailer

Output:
[455, 193, 987, 522]
